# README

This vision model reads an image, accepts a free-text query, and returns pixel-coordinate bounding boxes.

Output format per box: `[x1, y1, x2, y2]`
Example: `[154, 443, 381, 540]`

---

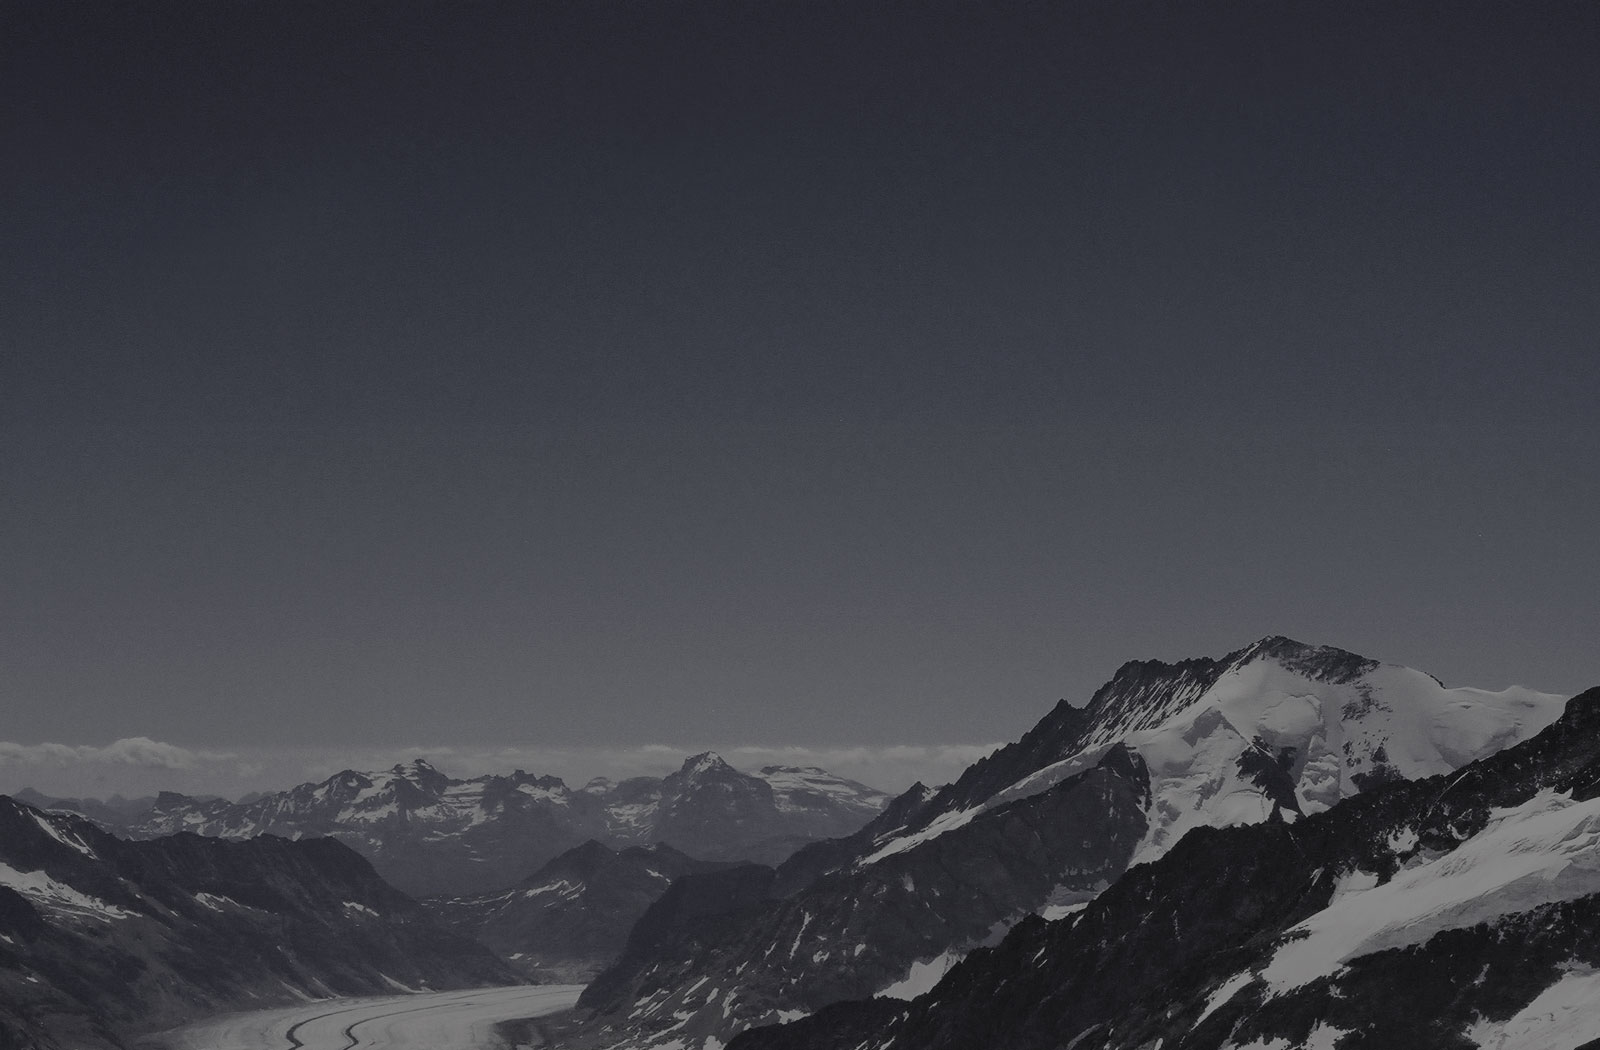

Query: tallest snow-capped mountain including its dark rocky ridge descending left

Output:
[566, 637, 1562, 1047]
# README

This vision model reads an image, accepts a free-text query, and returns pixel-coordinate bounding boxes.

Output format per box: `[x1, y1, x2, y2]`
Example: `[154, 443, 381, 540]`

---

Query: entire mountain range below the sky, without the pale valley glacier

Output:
[0, 635, 1600, 1050]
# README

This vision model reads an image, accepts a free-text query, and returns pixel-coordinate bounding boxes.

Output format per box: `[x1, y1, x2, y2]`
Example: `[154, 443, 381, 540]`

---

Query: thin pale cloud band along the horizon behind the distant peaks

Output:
[0, 736, 997, 797]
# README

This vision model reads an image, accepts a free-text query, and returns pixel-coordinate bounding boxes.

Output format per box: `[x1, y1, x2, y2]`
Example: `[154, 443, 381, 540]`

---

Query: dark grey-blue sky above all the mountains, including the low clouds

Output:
[0, 0, 1600, 794]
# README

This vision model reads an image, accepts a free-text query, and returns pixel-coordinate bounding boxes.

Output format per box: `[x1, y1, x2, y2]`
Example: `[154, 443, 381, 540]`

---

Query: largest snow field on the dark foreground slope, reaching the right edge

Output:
[1262, 791, 1600, 992]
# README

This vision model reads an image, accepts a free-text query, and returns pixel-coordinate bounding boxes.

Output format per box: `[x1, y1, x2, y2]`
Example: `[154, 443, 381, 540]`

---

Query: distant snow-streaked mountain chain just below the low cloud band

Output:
[65, 754, 888, 896]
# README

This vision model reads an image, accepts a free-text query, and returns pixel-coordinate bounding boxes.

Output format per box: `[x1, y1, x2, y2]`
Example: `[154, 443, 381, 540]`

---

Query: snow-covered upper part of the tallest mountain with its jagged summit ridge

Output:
[861, 637, 1565, 863]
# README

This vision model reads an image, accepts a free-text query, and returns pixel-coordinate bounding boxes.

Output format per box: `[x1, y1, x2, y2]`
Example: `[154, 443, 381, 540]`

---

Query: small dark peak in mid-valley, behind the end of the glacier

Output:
[422, 840, 726, 984]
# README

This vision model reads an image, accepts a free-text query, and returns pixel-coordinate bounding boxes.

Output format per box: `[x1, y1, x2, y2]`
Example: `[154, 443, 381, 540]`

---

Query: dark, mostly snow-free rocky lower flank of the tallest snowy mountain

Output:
[579, 747, 1149, 1042]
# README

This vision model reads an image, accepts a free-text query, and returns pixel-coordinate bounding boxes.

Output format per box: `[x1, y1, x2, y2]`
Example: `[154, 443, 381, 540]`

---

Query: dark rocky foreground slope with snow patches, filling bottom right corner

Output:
[730, 688, 1600, 1050]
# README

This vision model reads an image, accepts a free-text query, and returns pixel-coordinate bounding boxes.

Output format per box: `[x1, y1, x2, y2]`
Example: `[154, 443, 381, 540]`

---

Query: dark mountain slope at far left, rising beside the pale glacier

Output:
[0, 797, 517, 1050]
